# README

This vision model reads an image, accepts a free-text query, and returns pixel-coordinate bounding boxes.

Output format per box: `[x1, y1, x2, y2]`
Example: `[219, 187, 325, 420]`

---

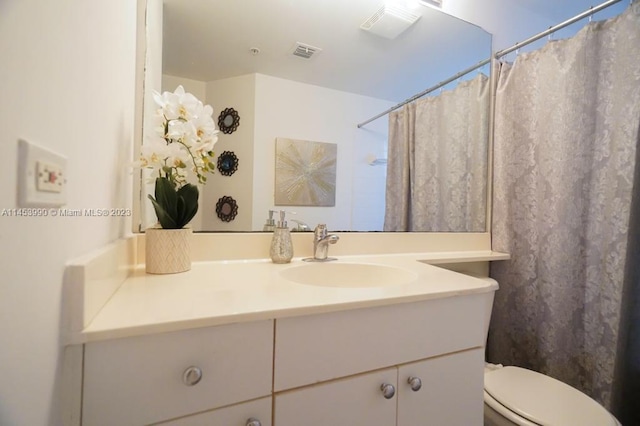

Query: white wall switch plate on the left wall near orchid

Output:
[18, 139, 67, 207]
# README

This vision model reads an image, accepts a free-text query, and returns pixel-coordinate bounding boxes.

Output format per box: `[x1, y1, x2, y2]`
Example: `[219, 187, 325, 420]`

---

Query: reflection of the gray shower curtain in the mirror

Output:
[384, 74, 490, 232]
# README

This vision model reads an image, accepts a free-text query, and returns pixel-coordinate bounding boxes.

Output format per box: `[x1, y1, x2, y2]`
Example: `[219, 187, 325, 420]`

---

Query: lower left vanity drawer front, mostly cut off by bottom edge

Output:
[157, 398, 271, 426]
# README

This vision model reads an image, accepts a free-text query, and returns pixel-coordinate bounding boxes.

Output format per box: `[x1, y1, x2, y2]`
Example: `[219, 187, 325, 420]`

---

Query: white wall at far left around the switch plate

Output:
[0, 0, 136, 426]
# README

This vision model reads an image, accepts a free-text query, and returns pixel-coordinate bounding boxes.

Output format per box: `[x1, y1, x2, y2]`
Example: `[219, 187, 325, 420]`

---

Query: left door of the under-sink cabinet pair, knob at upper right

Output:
[274, 368, 398, 426]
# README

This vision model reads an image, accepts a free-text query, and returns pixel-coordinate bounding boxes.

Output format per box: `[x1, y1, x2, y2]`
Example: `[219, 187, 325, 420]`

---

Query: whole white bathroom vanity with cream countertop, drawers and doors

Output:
[65, 236, 504, 426]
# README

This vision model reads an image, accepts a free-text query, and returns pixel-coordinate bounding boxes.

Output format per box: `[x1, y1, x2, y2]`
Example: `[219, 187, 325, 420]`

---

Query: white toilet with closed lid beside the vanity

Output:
[482, 278, 621, 426]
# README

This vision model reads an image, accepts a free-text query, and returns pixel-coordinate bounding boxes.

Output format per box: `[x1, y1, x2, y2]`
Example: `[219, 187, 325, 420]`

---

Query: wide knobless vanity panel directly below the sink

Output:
[274, 294, 485, 391]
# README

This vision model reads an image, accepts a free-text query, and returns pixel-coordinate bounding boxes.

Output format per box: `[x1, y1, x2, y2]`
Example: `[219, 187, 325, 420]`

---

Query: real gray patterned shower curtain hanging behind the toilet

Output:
[487, 2, 640, 416]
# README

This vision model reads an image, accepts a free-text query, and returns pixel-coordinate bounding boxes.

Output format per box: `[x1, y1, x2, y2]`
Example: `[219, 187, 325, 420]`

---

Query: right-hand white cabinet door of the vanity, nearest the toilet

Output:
[398, 348, 484, 426]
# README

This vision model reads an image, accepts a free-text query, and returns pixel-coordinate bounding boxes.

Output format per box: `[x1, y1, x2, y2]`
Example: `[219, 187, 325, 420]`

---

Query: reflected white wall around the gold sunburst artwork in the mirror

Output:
[253, 74, 393, 230]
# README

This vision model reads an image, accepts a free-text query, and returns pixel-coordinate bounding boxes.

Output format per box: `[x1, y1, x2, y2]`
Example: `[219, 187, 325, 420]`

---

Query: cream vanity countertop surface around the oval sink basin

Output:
[79, 253, 497, 343]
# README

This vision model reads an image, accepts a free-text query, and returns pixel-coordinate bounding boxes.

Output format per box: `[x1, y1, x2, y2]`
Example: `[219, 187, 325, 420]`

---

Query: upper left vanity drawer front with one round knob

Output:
[82, 321, 273, 426]
